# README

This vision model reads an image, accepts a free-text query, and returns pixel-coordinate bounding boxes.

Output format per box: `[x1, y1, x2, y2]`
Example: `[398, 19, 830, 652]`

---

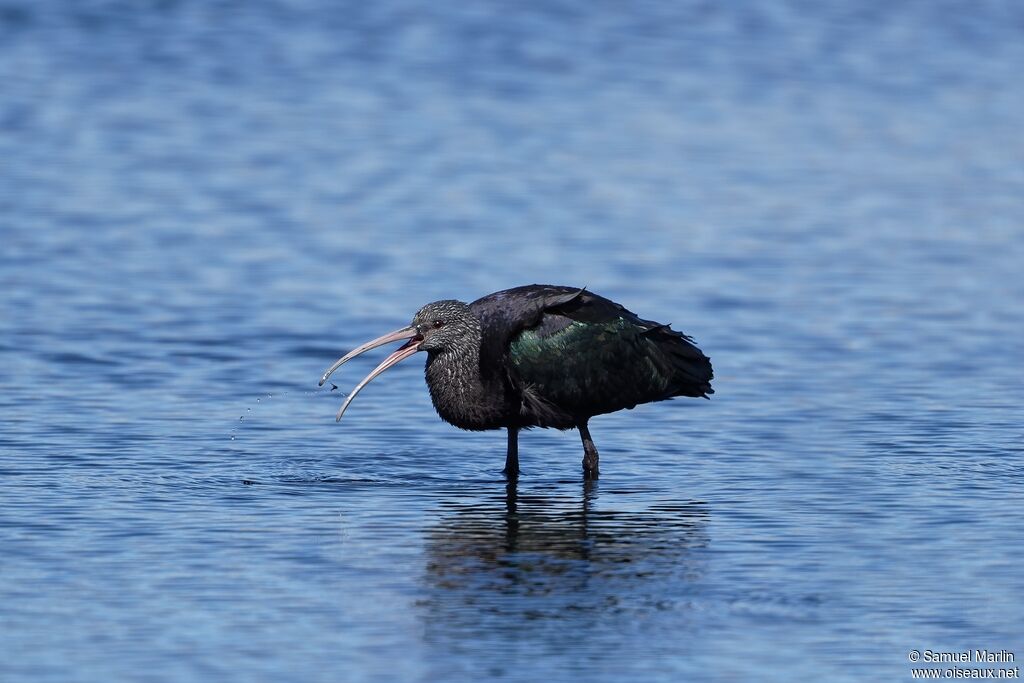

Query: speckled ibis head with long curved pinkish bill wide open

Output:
[319, 299, 480, 420]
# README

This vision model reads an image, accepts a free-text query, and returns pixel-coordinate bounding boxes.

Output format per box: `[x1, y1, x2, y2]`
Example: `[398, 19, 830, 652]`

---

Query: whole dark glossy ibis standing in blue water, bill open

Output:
[319, 285, 715, 478]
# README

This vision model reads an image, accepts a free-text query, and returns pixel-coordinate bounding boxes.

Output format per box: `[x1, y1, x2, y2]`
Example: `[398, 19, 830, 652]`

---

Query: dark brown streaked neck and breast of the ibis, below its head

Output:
[426, 328, 509, 430]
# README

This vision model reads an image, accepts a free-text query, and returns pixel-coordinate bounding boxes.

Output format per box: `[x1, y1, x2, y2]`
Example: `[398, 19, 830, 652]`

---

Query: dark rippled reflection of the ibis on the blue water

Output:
[420, 481, 710, 639]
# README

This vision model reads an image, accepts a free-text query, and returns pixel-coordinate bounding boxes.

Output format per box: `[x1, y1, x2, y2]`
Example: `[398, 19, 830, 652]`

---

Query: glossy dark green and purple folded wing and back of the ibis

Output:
[470, 285, 713, 428]
